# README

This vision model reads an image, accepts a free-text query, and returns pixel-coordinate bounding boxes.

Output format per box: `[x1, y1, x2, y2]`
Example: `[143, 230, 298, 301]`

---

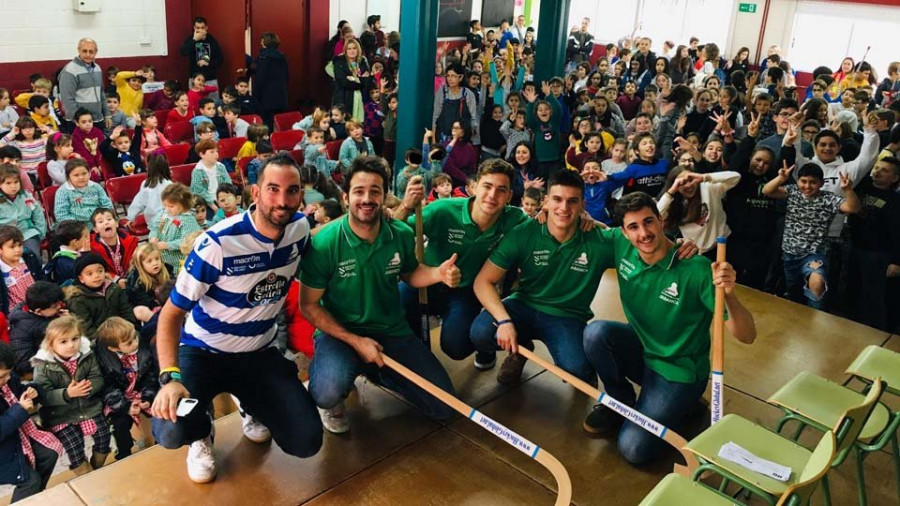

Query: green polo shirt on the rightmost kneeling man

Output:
[615, 235, 715, 383]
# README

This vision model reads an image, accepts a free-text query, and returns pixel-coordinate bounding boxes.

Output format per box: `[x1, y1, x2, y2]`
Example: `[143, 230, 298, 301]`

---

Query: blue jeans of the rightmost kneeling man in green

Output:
[584, 320, 708, 465]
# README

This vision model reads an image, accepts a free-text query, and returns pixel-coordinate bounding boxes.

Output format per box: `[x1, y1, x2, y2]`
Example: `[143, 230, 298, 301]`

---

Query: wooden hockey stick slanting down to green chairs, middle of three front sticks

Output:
[519, 346, 700, 478]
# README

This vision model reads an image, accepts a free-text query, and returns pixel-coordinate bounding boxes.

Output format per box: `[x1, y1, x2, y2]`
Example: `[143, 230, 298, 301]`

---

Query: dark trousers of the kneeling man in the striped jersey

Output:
[153, 346, 322, 457]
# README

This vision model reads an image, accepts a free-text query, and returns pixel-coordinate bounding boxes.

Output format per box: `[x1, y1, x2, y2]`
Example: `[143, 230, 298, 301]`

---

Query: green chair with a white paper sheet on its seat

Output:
[685, 378, 882, 505]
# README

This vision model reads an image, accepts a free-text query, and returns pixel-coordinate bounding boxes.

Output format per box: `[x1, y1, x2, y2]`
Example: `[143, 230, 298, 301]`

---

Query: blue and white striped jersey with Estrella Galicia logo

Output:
[170, 206, 309, 353]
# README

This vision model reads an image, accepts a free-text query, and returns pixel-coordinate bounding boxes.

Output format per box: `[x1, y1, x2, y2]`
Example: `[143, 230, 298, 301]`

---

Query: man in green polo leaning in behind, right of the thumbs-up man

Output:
[394, 158, 528, 370]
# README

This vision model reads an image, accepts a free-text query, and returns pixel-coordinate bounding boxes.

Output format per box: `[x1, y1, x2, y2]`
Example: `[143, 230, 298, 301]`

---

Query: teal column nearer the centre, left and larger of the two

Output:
[394, 0, 438, 178]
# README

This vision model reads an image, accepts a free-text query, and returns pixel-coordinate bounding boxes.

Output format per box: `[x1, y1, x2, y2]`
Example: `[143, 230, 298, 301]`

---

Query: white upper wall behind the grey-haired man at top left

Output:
[0, 0, 167, 63]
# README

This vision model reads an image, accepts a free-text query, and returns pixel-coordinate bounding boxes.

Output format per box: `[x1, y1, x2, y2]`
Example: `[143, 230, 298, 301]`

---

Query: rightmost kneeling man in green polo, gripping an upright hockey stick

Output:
[584, 192, 756, 464]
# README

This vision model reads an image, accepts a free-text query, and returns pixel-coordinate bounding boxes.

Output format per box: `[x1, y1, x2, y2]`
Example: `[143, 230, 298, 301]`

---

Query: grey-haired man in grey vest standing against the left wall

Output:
[59, 38, 109, 127]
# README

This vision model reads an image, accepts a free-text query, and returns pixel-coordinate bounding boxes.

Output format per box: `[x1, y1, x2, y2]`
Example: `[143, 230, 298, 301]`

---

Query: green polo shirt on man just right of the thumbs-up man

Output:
[406, 197, 528, 287]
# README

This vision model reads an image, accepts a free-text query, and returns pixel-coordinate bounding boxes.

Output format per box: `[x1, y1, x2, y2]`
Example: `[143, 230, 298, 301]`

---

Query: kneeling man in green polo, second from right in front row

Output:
[471, 171, 617, 385]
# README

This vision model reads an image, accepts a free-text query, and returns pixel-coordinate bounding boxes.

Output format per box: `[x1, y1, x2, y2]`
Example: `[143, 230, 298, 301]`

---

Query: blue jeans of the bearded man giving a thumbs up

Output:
[309, 333, 456, 421]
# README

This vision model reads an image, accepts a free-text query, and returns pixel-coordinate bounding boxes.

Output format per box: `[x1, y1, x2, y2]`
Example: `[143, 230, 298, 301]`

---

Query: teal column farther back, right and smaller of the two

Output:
[534, 0, 571, 83]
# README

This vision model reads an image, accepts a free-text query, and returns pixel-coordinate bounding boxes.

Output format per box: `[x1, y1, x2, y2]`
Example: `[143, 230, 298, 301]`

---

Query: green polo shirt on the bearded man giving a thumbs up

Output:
[300, 216, 419, 337]
